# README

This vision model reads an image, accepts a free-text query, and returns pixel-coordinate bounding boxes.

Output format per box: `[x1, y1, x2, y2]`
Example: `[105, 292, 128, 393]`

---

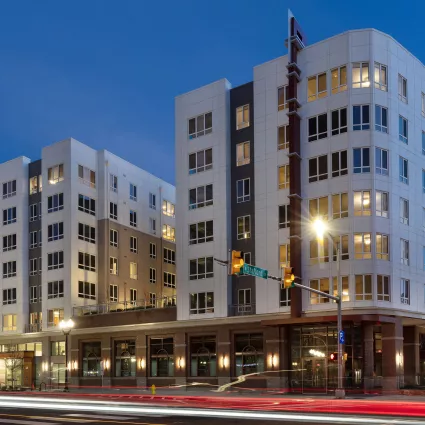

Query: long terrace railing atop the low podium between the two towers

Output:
[73, 297, 176, 316]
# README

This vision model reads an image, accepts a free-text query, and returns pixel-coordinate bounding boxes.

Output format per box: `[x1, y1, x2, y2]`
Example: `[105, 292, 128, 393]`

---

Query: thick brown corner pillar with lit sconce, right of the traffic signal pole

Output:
[381, 317, 403, 391]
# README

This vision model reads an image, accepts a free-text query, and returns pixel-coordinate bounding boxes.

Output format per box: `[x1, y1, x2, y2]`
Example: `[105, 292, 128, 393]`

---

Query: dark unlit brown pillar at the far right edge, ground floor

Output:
[403, 326, 420, 385]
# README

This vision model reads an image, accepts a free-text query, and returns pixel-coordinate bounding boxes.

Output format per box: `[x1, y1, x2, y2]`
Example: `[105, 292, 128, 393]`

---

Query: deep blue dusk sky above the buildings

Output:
[0, 0, 425, 183]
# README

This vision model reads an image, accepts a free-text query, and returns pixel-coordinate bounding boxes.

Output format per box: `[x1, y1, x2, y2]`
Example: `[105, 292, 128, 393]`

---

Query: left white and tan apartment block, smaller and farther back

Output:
[0, 139, 176, 386]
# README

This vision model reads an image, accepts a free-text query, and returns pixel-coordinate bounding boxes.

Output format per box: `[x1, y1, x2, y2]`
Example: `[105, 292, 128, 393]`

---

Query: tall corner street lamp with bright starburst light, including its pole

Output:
[313, 219, 345, 398]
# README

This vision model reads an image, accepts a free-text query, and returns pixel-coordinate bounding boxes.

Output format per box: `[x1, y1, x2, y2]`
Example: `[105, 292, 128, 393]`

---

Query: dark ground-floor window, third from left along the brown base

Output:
[149, 336, 174, 377]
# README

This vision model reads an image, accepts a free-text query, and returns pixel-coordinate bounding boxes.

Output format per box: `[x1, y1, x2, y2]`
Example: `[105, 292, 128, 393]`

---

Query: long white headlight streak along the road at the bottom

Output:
[0, 397, 424, 425]
